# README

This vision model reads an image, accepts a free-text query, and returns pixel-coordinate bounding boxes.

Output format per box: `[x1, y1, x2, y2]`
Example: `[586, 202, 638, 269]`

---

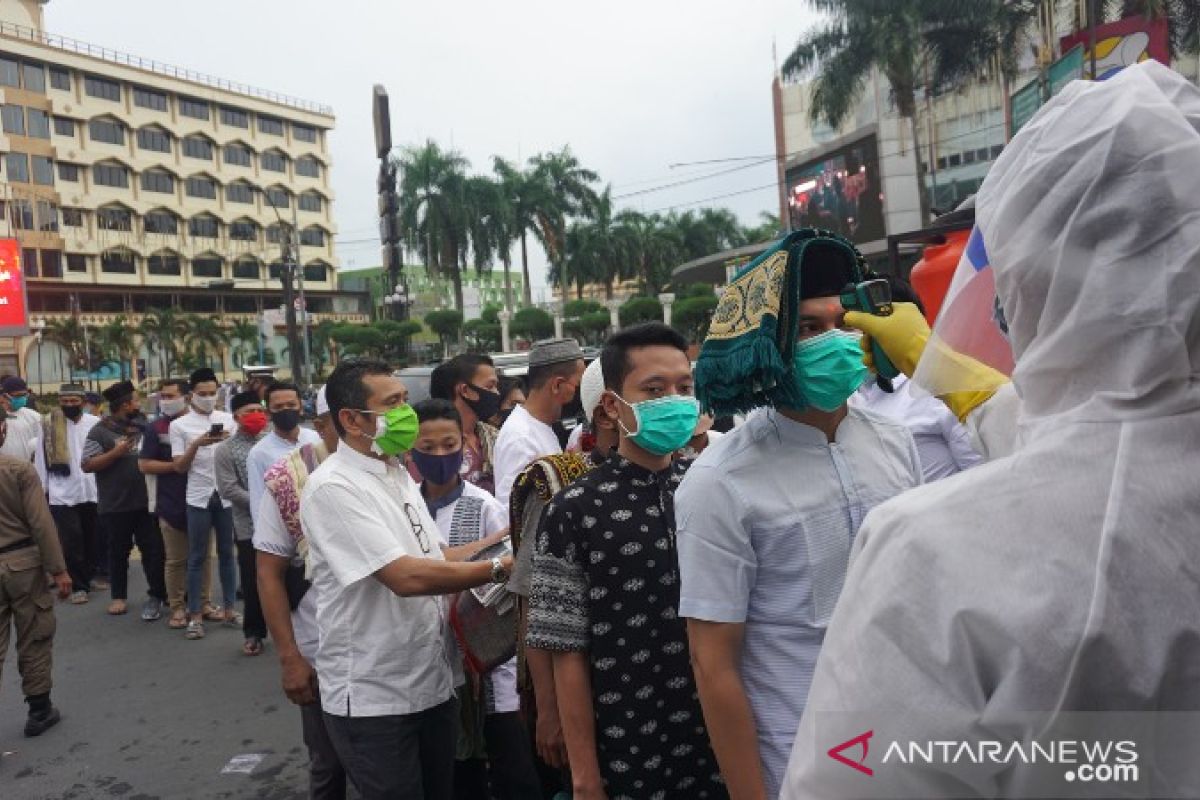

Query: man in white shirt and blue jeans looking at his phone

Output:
[168, 368, 241, 639]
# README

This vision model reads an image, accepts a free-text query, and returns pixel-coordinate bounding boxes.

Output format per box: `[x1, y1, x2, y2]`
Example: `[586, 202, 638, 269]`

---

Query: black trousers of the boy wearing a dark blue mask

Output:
[454, 711, 542, 800]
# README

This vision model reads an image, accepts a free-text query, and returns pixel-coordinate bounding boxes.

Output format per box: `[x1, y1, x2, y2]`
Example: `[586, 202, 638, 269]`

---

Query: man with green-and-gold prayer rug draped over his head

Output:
[676, 230, 922, 798]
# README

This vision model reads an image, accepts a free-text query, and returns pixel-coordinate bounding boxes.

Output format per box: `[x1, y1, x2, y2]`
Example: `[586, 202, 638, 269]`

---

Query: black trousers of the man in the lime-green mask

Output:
[325, 697, 458, 800]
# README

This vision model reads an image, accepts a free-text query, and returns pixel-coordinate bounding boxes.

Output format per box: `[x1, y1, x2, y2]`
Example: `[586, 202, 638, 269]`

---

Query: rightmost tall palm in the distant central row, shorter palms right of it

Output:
[529, 146, 600, 308]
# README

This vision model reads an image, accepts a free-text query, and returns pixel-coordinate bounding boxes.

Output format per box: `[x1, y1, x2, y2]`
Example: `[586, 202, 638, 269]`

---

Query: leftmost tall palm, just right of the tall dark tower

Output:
[398, 139, 470, 311]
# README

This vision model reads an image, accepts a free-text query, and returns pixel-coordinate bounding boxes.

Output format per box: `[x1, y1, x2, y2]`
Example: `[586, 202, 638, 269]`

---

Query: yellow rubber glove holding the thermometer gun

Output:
[846, 302, 1009, 421]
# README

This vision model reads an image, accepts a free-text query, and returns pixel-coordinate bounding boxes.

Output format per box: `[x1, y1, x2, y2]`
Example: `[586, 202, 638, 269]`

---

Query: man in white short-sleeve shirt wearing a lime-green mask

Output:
[300, 361, 511, 800]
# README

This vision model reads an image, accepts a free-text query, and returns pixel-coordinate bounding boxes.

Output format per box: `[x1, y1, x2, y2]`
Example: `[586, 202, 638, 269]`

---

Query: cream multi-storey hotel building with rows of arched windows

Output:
[0, 0, 365, 383]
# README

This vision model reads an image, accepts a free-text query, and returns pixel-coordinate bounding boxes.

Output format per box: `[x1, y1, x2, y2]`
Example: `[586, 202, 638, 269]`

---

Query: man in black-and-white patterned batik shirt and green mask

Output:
[526, 323, 726, 800]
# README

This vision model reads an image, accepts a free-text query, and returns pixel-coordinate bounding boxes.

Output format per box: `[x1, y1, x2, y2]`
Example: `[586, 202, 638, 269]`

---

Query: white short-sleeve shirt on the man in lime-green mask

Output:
[300, 446, 454, 717]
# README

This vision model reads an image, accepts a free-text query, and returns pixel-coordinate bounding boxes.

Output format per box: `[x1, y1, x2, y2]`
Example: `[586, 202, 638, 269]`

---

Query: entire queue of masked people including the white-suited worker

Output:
[0, 64, 1200, 800]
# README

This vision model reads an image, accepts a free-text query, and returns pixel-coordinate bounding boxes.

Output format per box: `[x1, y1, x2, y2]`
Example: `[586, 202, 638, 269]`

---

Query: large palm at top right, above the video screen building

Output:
[782, 0, 1038, 224]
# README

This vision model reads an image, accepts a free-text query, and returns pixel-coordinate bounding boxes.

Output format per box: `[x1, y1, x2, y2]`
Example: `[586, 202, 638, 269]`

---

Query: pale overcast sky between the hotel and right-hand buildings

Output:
[46, 0, 811, 297]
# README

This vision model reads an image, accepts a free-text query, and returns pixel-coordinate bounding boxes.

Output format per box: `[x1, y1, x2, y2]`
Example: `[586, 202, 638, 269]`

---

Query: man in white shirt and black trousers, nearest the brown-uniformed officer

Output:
[34, 384, 100, 604]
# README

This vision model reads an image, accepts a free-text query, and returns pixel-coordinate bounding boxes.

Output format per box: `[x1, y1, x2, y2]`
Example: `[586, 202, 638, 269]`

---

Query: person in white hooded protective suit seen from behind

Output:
[782, 61, 1200, 799]
